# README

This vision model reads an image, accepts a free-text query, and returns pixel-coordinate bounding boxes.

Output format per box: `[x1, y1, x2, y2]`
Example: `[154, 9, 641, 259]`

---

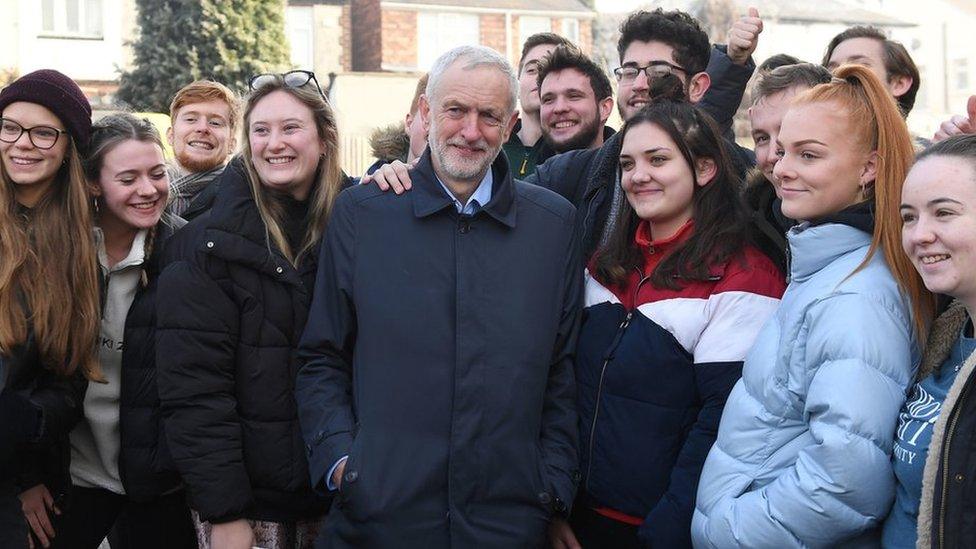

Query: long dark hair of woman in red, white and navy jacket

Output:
[593, 74, 752, 289]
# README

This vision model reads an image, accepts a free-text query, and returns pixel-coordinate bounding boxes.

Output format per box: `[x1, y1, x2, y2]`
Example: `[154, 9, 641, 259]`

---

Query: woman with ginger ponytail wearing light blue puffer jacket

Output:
[692, 66, 933, 547]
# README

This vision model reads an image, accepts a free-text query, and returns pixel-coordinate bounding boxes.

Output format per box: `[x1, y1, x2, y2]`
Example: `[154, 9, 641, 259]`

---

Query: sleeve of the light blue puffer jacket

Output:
[696, 293, 917, 548]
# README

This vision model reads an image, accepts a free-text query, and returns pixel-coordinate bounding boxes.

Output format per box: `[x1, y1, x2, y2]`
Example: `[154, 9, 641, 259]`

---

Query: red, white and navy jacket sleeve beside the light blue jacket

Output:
[638, 270, 783, 547]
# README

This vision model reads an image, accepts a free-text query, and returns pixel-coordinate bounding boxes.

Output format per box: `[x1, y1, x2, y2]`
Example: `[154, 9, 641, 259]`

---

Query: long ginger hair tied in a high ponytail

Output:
[793, 65, 935, 342]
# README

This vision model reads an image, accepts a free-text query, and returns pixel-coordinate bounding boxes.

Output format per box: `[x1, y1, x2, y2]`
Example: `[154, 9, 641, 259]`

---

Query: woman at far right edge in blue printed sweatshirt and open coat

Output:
[884, 135, 976, 547]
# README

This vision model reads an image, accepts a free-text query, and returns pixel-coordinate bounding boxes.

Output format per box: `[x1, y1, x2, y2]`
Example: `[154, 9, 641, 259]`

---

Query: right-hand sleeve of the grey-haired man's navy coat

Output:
[540, 212, 583, 512]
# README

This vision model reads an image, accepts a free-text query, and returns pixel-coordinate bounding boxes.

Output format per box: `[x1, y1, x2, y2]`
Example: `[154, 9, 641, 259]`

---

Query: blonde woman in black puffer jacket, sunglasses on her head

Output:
[157, 71, 345, 548]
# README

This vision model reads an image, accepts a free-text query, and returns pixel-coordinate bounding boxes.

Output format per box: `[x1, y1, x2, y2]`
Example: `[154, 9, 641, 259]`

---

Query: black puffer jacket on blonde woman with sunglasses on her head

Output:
[156, 162, 327, 522]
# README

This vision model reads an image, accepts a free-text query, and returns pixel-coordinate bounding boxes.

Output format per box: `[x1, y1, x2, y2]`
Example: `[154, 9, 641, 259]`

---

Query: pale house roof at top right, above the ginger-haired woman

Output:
[748, 0, 916, 27]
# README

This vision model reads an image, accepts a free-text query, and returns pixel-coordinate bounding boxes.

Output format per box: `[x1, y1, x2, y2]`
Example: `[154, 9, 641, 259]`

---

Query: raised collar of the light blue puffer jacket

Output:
[786, 221, 871, 281]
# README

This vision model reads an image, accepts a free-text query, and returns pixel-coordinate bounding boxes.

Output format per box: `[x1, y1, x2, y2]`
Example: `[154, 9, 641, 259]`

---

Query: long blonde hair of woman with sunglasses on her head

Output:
[241, 77, 343, 266]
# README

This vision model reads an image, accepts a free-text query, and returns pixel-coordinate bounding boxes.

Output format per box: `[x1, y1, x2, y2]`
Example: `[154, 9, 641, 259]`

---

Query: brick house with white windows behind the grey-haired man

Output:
[349, 0, 595, 72]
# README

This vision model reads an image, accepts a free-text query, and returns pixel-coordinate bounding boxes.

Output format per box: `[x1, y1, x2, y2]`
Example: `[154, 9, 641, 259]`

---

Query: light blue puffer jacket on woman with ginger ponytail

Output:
[692, 223, 919, 548]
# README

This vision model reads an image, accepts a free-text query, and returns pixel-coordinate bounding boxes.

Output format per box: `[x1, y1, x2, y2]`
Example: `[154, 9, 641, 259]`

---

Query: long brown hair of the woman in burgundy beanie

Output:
[0, 137, 102, 380]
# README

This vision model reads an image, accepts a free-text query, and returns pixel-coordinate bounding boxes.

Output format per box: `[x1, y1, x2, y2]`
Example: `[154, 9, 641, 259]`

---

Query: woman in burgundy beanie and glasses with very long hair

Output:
[0, 70, 101, 548]
